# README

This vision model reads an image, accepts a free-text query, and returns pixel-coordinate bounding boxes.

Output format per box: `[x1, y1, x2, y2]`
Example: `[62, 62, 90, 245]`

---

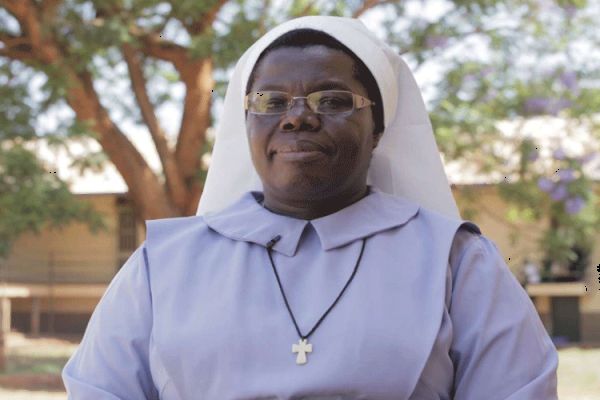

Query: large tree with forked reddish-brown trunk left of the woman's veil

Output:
[0, 0, 390, 225]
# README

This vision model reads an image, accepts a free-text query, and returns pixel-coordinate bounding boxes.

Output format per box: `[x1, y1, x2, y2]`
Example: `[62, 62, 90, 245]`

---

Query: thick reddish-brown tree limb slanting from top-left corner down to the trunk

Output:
[0, 0, 185, 219]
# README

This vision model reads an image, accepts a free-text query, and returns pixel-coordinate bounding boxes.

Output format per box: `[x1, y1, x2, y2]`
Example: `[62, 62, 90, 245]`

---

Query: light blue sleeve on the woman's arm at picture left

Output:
[62, 247, 158, 400]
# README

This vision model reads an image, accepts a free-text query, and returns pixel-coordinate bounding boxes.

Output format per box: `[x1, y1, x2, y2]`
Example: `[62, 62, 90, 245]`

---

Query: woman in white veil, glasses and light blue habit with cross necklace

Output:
[63, 17, 557, 400]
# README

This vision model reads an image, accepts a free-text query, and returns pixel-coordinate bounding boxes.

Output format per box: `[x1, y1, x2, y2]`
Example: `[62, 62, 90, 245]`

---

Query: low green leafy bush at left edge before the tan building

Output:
[0, 65, 104, 260]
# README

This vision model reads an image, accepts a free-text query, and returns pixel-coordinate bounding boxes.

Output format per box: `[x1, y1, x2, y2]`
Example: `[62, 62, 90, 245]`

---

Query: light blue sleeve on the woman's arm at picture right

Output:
[449, 231, 558, 400]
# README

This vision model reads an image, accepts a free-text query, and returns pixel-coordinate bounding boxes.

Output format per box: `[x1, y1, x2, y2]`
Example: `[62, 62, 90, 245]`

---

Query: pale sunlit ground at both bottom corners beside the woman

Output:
[0, 332, 600, 400]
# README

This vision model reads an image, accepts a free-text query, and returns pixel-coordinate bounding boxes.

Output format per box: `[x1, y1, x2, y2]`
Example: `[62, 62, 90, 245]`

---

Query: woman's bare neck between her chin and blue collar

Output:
[263, 185, 369, 220]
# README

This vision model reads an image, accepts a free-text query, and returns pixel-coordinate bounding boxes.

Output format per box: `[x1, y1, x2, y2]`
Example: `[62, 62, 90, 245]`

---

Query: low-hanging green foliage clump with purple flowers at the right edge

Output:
[499, 146, 600, 279]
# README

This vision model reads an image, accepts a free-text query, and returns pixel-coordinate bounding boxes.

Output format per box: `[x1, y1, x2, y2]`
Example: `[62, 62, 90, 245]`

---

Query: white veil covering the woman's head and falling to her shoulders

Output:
[198, 16, 459, 218]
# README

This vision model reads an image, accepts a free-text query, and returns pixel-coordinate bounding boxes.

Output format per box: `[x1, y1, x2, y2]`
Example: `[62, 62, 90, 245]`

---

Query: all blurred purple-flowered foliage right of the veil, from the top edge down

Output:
[378, 0, 600, 276]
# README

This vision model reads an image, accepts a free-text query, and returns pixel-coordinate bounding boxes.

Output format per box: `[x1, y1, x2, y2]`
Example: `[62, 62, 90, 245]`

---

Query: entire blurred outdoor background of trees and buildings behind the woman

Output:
[0, 0, 600, 400]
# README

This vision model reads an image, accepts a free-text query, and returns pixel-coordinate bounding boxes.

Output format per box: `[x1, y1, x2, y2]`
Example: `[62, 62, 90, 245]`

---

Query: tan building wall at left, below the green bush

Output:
[0, 194, 145, 333]
